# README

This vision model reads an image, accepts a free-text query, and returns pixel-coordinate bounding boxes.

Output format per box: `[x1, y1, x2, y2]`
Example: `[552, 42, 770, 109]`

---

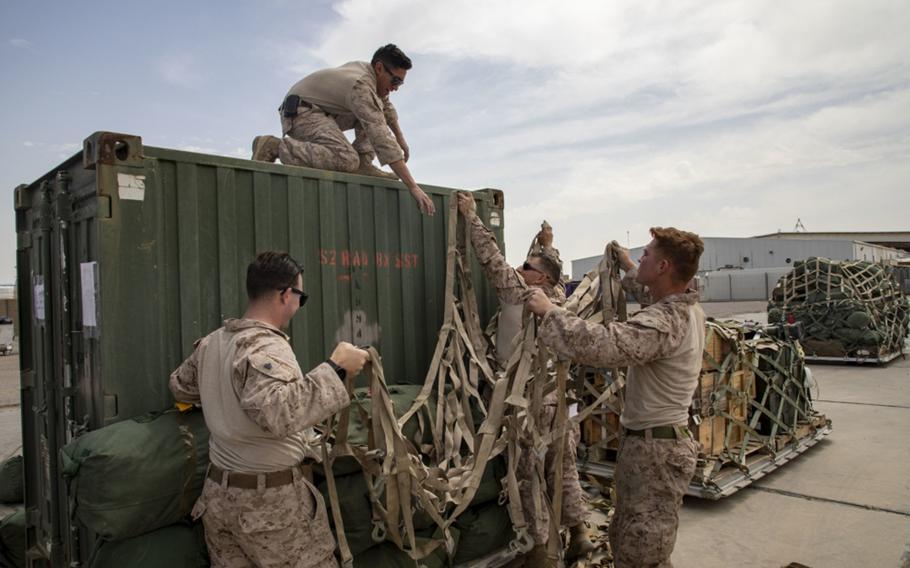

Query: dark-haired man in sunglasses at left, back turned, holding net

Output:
[170, 252, 368, 568]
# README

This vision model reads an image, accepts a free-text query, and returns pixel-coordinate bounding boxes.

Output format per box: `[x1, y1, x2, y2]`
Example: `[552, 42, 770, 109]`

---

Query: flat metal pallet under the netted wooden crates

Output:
[578, 423, 832, 501]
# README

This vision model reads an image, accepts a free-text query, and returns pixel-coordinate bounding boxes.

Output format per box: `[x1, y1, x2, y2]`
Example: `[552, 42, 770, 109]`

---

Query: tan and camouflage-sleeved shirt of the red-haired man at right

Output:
[540, 270, 705, 430]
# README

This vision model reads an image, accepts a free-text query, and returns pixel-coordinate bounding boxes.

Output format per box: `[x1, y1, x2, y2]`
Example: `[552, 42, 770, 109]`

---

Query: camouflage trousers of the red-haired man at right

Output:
[610, 436, 698, 568]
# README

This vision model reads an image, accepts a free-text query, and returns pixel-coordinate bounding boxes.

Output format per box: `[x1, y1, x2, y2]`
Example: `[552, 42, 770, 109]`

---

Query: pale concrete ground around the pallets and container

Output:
[0, 302, 910, 568]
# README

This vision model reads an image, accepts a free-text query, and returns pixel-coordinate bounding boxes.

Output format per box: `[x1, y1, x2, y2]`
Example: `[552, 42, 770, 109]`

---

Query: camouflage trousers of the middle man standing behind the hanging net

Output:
[515, 405, 588, 544]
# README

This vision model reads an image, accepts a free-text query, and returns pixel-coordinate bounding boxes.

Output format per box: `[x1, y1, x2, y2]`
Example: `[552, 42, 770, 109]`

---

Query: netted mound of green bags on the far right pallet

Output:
[768, 257, 910, 359]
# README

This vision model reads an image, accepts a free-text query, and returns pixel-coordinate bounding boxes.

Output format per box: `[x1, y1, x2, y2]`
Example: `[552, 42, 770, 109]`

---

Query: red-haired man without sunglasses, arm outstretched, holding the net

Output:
[527, 227, 705, 568]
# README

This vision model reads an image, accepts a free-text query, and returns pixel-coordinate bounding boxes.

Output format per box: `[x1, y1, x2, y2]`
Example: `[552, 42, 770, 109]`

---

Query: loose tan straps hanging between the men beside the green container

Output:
[323, 196, 636, 565]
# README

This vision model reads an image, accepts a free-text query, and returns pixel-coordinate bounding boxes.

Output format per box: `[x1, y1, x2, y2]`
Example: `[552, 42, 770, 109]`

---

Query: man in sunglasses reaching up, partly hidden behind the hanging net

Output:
[457, 193, 593, 566]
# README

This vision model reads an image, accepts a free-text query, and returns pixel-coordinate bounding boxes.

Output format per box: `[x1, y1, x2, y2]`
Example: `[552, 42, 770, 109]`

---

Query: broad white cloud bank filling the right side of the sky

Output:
[309, 0, 910, 261]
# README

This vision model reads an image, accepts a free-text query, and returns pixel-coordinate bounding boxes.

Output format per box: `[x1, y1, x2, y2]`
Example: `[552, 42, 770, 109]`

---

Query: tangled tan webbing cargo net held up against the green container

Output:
[323, 198, 621, 566]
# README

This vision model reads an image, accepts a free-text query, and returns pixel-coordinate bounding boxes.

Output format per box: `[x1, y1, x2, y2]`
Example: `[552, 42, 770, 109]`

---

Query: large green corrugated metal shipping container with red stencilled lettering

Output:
[15, 132, 503, 566]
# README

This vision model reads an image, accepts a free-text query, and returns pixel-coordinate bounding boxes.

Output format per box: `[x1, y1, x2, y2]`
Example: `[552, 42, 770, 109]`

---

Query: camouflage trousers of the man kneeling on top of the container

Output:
[278, 107, 374, 172]
